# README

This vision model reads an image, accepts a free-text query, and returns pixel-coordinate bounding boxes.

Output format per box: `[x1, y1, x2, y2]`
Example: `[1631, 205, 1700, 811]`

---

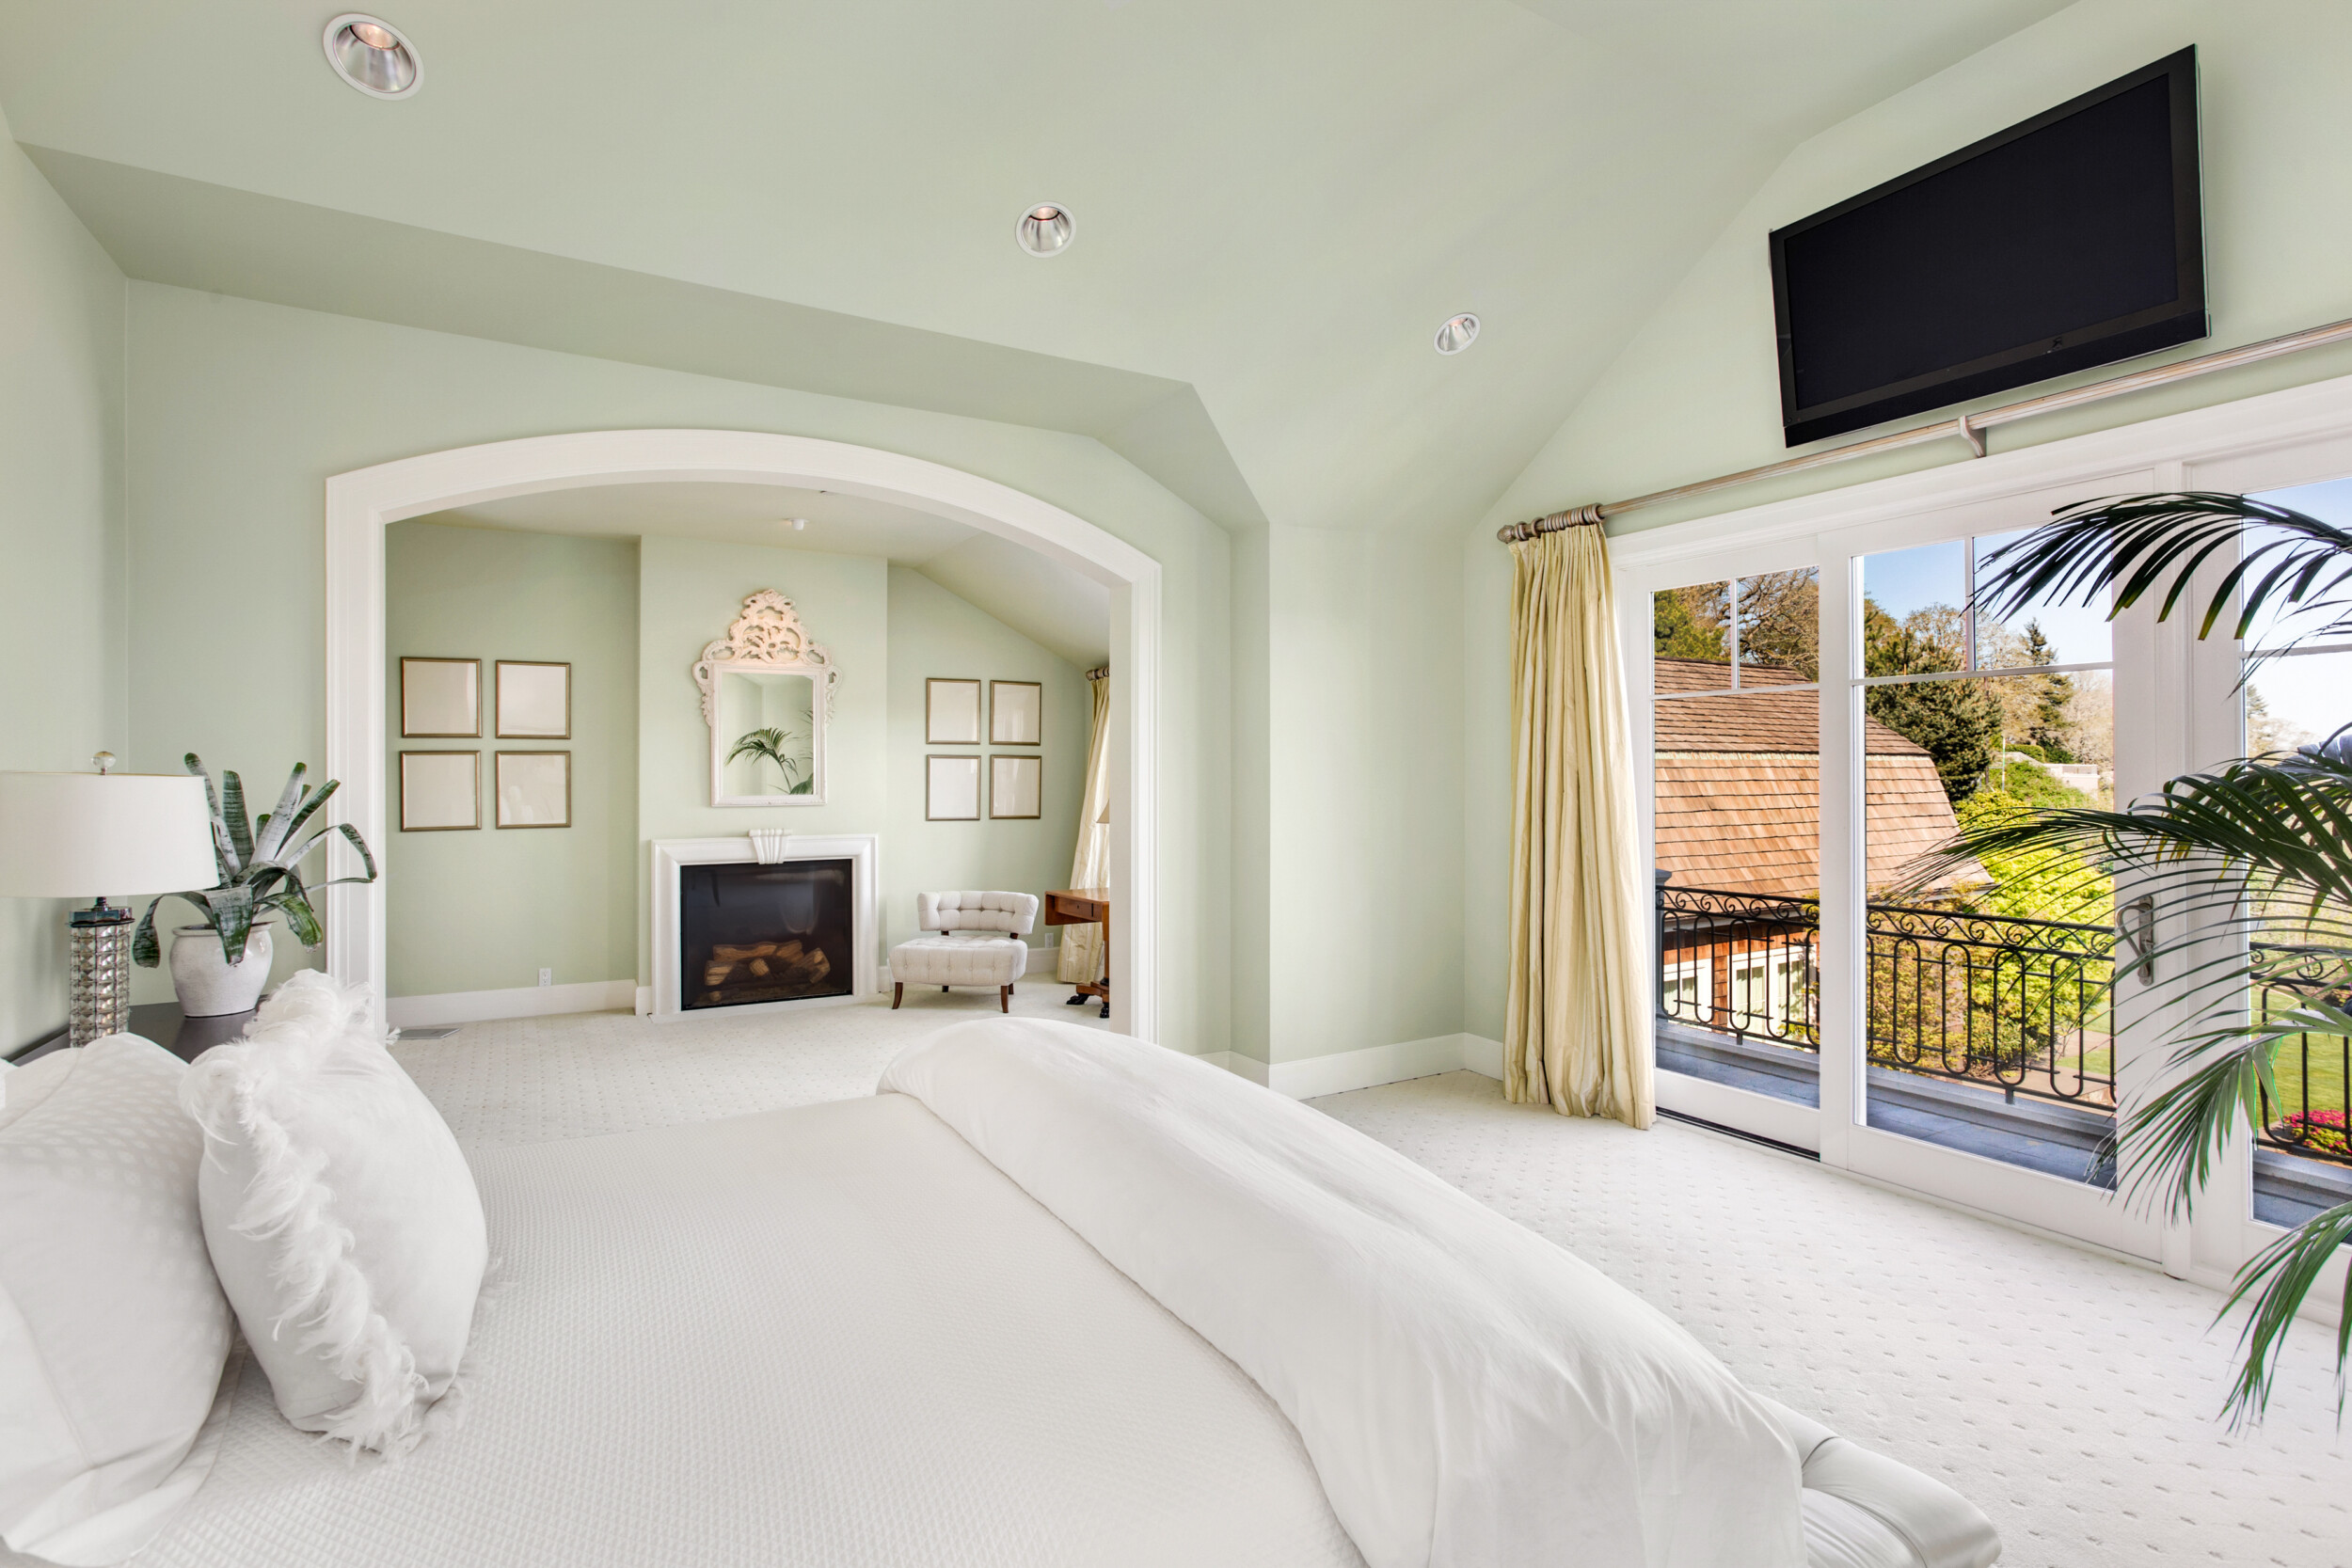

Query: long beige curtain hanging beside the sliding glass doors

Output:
[1503, 524, 1656, 1126]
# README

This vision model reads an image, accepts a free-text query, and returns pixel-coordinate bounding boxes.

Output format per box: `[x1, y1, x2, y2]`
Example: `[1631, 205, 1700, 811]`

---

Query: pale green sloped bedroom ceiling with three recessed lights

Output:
[0, 0, 2058, 540]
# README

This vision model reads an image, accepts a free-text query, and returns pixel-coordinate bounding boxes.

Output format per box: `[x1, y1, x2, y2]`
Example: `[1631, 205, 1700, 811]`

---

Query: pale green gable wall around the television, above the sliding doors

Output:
[1463, 0, 2352, 1035]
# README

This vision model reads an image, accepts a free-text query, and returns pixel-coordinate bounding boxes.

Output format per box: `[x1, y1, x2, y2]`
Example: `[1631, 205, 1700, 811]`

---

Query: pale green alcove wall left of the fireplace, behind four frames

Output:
[376, 522, 638, 997]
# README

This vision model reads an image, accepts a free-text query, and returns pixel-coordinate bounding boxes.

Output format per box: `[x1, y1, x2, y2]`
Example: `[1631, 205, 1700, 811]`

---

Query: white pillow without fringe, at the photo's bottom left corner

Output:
[0, 1035, 235, 1563]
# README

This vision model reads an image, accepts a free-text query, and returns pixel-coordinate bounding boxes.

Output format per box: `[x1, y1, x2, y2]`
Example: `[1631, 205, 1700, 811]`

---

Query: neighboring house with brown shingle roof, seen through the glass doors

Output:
[1651, 658, 1966, 1044]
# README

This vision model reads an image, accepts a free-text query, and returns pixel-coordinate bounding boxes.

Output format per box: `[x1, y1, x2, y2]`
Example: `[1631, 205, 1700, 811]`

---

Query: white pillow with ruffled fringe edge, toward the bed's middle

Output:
[182, 971, 489, 1453]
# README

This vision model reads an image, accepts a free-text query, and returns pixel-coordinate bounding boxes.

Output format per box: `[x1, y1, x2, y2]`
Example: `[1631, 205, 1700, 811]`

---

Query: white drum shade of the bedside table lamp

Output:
[0, 773, 221, 898]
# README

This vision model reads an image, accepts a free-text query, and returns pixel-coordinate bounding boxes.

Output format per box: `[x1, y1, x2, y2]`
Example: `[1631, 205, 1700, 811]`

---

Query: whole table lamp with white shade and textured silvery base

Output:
[0, 752, 221, 1046]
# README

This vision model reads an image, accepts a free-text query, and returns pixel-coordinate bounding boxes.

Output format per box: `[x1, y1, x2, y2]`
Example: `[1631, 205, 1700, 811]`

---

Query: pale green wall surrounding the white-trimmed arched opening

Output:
[130, 282, 1231, 1051]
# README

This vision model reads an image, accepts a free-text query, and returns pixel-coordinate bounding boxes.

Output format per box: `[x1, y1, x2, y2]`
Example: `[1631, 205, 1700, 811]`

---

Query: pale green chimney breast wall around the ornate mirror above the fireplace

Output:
[638, 538, 892, 983]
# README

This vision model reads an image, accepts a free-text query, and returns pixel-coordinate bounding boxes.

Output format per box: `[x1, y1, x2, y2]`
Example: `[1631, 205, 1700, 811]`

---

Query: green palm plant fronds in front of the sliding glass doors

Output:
[1922, 491, 2352, 1425]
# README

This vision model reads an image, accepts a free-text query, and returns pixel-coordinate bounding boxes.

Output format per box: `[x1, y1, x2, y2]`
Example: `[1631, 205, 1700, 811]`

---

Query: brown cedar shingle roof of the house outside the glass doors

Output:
[1654, 658, 1960, 895]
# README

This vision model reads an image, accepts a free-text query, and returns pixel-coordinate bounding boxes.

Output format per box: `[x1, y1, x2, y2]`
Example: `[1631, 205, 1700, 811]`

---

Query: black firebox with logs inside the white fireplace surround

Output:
[677, 861, 854, 1011]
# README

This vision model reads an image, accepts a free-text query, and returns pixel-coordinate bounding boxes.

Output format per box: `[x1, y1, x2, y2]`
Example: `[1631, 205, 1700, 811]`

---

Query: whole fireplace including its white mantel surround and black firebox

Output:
[640, 832, 878, 1018]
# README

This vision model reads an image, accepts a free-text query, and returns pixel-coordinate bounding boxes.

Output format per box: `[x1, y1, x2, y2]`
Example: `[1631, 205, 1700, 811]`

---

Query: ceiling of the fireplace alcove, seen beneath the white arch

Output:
[419, 482, 1110, 668]
